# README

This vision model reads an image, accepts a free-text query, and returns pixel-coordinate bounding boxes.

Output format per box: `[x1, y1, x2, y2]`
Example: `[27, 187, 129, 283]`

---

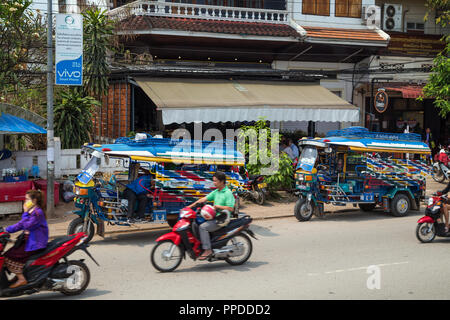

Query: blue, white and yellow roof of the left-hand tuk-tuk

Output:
[83, 134, 245, 166]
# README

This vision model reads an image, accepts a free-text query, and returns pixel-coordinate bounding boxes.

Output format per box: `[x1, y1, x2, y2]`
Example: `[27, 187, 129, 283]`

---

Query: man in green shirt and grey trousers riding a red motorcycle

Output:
[188, 171, 235, 260]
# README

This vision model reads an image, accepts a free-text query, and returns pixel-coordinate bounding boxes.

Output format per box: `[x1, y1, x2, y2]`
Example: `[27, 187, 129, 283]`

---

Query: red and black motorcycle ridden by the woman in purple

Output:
[0, 227, 98, 297]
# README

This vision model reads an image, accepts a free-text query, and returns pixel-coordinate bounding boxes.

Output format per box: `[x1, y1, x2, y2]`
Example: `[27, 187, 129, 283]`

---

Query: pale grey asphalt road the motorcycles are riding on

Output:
[4, 210, 450, 300]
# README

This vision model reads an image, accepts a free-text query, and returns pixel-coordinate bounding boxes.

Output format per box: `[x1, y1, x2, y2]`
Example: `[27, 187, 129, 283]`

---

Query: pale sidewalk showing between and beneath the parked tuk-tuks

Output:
[0, 179, 445, 239]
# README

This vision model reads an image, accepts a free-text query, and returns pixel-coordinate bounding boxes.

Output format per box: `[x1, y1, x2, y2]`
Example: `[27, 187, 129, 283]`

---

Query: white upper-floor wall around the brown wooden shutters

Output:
[288, 0, 375, 29]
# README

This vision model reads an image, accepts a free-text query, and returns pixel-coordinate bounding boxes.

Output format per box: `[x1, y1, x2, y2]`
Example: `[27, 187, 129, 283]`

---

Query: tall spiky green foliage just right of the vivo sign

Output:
[82, 8, 114, 100]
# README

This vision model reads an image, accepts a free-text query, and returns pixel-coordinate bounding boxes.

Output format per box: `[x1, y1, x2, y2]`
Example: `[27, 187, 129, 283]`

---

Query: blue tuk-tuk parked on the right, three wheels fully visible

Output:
[294, 127, 431, 221]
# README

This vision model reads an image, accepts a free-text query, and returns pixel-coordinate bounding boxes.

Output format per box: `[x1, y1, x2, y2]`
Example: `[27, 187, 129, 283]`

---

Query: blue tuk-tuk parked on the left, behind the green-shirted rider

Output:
[67, 134, 245, 240]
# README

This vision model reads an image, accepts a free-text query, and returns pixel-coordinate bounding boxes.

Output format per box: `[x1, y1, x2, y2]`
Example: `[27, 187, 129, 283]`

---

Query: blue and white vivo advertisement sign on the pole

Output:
[55, 14, 83, 86]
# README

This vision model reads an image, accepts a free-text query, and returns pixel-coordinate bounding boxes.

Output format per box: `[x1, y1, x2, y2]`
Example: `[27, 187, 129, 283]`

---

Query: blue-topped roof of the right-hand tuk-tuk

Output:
[299, 127, 431, 154]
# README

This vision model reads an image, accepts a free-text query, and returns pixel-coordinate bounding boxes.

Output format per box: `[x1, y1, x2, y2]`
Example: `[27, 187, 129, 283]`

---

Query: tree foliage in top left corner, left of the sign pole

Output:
[0, 0, 46, 91]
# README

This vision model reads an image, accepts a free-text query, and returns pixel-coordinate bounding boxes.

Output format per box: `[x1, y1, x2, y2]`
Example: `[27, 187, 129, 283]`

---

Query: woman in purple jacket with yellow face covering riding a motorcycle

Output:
[5, 190, 48, 288]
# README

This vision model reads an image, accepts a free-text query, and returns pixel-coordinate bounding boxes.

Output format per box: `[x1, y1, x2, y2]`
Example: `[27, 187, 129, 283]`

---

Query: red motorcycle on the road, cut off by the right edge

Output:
[416, 194, 450, 243]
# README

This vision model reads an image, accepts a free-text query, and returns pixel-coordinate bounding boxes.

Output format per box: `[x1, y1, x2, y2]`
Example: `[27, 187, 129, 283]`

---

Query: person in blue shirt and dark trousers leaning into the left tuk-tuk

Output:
[124, 165, 152, 222]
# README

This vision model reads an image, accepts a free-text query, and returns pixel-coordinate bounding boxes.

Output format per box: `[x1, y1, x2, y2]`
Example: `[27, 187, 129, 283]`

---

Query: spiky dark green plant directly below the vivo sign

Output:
[54, 89, 100, 149]
